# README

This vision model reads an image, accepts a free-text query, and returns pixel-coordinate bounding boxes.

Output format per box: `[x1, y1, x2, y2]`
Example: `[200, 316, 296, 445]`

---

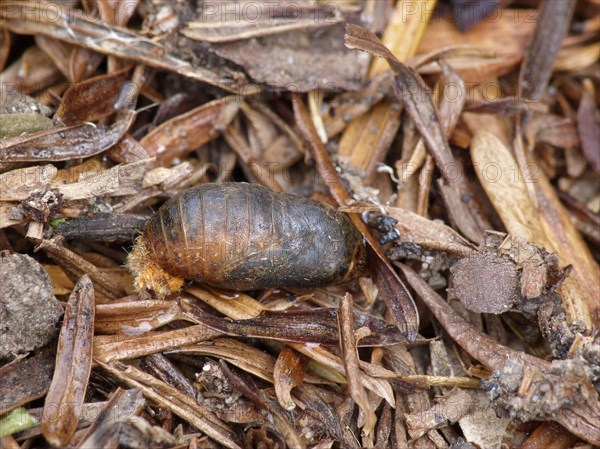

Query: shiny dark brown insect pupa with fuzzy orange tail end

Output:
[128, 183, 366, 298]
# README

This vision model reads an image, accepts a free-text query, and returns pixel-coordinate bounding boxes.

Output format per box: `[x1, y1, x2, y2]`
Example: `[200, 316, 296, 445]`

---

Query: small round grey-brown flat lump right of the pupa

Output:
[448, 252, 519, 313]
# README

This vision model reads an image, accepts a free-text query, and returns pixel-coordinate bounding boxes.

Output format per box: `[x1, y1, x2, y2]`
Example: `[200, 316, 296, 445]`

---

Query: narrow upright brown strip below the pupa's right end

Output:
[338, 293, 377, 435]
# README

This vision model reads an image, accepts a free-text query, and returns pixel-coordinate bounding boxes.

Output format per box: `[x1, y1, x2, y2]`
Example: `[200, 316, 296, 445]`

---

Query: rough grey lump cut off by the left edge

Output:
[0, 251, 63, 359]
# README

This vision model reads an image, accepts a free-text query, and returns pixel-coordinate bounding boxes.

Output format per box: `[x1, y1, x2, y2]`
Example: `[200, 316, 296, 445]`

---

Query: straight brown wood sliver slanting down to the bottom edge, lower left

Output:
[99, 362, 242, 449]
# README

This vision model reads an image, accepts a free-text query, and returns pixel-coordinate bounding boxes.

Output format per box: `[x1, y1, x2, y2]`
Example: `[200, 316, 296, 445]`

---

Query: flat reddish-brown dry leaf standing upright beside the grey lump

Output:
[41, 275, 94, 447]
